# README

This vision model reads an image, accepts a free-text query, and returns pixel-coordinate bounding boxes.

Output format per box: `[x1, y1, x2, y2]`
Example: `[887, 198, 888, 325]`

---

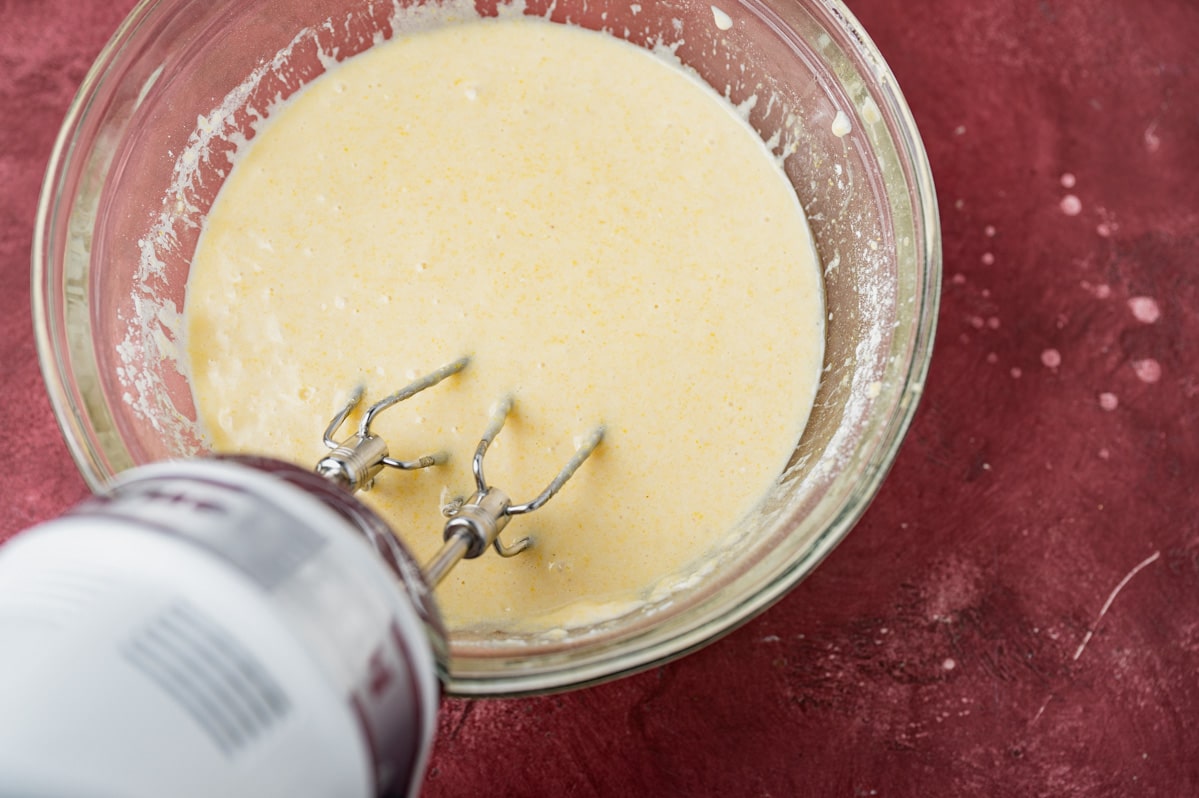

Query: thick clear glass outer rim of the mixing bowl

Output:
[30, 0, 942, 696]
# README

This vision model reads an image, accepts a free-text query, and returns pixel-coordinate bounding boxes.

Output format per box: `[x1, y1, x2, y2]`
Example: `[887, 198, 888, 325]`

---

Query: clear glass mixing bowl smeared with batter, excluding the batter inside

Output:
[32, 0, 941, 695]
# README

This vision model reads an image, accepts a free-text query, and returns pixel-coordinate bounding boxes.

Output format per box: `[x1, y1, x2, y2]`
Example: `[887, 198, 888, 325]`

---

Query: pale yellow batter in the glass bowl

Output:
[185, 19, 824, 629]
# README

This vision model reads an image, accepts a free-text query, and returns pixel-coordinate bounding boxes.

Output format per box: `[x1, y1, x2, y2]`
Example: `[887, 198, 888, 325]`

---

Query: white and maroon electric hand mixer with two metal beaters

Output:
[0, 358, 603, 798]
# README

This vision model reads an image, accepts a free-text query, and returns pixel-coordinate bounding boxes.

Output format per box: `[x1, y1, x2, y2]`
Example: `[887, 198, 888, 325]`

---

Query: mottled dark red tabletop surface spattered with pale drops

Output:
[0, 0, 1199, 797]
